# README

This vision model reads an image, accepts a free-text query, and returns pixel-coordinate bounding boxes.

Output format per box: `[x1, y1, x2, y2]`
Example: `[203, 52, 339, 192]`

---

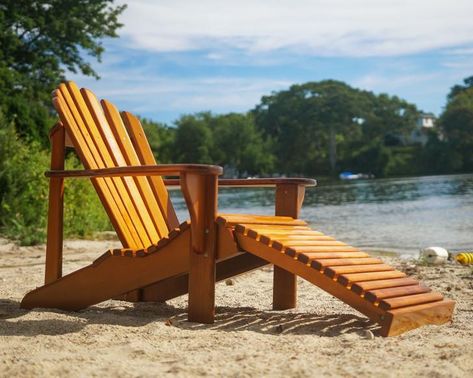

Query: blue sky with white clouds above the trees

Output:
[69, 0, 473, 124]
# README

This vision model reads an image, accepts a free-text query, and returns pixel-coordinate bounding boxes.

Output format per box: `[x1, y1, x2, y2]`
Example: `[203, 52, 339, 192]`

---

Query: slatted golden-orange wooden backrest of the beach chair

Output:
[53, 82, 178, 249]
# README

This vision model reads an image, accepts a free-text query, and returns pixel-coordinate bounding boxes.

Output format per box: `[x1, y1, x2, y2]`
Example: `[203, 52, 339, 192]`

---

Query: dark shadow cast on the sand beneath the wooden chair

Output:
[0, 299, 378, 337]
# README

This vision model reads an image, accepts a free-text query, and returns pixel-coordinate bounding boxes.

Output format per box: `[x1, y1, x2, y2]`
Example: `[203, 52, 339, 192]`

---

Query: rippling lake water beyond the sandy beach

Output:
[172, 175, 473, 256]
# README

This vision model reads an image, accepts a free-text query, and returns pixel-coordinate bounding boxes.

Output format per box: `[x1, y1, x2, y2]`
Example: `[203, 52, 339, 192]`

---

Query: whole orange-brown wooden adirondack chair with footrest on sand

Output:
[21, 82, 454, 336]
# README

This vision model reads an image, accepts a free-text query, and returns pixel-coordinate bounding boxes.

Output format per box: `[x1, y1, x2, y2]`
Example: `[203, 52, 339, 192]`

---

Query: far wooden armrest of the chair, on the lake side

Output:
[164, 177, 317, 188]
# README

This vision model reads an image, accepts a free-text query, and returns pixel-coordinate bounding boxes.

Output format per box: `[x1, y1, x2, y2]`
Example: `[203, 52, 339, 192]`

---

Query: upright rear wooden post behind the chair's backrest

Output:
[44, 123, 66, 284]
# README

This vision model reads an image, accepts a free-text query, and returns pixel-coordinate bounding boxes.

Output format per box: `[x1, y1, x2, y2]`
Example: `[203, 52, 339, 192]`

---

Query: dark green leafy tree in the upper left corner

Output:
[0, 0, 125, 145]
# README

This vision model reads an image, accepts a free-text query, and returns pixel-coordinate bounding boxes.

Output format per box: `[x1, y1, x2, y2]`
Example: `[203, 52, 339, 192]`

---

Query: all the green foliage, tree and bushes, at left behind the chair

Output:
[0, 0, 124, 244]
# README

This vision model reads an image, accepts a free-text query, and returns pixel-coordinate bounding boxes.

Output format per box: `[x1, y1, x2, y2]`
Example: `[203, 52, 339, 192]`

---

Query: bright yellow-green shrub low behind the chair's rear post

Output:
[0, 115, 111, 245]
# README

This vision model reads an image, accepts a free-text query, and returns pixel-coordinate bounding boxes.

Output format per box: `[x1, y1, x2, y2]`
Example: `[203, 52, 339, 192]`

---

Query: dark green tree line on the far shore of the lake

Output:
[143, 77, 473, 177]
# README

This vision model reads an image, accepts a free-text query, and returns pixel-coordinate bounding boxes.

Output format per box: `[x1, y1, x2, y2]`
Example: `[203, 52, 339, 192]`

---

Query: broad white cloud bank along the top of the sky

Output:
[116, 0, 473, 57]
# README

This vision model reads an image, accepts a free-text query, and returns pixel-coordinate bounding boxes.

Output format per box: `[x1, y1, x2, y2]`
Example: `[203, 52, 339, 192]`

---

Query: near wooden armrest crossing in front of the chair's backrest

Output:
[45, 164, 223, 178]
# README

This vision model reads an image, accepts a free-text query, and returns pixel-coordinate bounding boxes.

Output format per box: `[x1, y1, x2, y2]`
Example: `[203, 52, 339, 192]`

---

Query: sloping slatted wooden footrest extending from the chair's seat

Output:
[232, 217, 455, 336]
